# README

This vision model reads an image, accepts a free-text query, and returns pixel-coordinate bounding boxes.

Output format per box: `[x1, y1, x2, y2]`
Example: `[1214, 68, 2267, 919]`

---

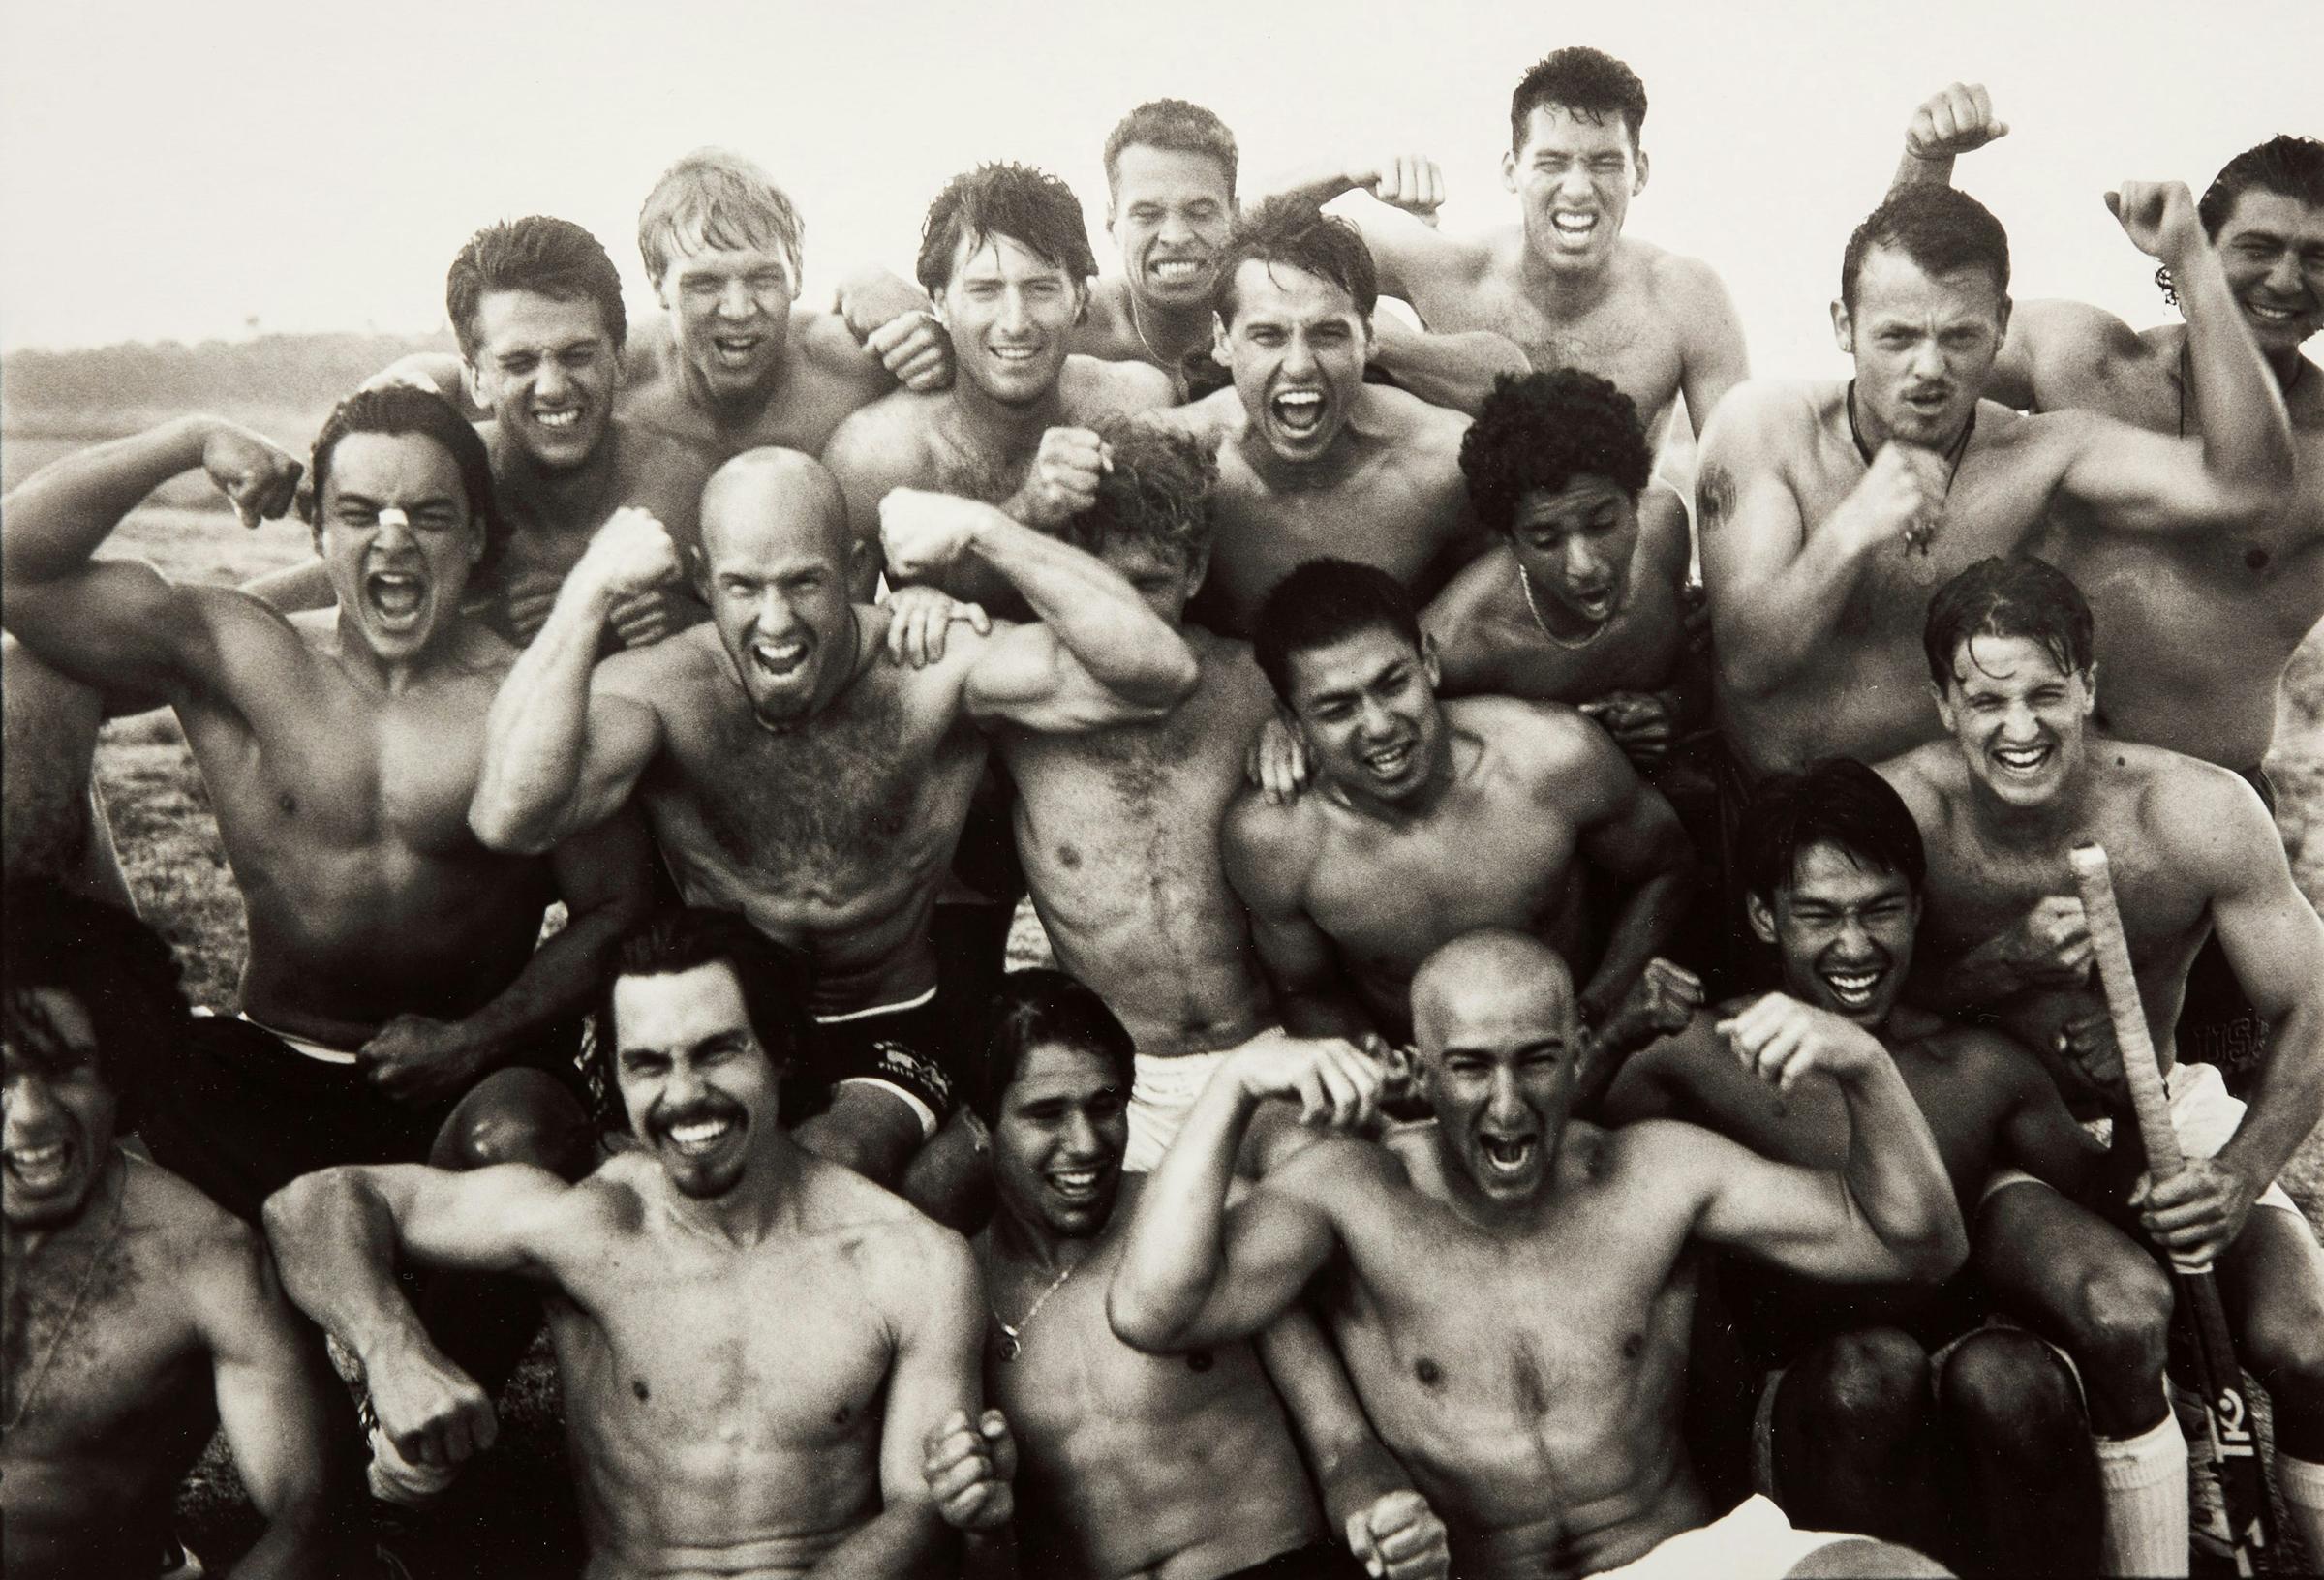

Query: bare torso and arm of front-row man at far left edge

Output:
[0, 1134, 355, 1580]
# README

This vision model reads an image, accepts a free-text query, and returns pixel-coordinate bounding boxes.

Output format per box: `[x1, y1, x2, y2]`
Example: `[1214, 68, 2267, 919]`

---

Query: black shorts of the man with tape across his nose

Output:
[138, 1016, 588, 1222]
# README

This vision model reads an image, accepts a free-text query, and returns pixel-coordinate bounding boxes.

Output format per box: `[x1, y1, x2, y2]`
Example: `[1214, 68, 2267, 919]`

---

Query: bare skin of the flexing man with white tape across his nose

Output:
[5, 418, 649, 1059]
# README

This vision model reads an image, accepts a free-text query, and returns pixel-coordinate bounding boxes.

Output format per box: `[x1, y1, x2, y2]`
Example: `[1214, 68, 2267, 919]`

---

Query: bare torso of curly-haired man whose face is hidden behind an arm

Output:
[997, 625, 1273, 1057]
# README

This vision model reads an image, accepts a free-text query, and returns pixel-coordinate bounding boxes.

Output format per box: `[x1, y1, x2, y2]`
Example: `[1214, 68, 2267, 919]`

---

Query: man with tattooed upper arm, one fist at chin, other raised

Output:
[1697, 181, 2291, 778]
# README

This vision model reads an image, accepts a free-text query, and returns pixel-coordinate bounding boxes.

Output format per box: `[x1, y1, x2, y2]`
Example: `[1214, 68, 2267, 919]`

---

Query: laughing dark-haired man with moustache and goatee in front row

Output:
[267, 911, 981, 1580]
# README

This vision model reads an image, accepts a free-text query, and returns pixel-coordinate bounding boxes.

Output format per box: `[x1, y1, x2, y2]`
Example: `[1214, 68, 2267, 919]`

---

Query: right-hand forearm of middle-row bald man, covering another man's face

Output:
[969, 509, 1197, 707]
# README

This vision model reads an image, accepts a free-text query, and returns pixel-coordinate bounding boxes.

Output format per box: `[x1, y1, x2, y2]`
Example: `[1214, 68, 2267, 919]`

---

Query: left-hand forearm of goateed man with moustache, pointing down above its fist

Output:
[265, 1169, 423, 1357]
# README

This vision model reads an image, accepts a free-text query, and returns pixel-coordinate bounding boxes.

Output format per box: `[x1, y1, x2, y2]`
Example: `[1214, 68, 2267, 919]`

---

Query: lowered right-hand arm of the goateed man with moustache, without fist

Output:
[807, 1220, 986, 1580]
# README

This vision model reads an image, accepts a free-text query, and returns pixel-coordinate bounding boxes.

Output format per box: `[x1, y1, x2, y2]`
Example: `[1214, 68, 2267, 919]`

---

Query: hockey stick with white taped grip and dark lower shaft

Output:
[2070, 843, 2268, 1575]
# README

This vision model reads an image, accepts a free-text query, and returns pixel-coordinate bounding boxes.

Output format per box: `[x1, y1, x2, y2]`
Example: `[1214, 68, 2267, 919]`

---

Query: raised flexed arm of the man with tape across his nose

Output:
[0, 416, 300, 697]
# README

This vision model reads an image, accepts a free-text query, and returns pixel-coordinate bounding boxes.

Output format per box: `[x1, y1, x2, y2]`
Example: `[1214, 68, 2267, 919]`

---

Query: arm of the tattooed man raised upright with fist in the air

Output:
[2050, 181, 2294, 532]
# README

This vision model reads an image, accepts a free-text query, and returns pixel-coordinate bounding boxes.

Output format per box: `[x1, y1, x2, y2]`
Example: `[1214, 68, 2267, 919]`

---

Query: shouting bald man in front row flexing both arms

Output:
[1109, 931, 1966, 1580]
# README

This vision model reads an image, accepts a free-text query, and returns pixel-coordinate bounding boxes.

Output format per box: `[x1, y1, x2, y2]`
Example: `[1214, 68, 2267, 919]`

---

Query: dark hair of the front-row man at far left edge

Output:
[0, 878, 193, 1132]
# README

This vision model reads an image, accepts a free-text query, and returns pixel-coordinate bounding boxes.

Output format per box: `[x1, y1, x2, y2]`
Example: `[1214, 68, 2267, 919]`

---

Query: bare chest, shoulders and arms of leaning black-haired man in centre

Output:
[1220, 697, 1690, 1044]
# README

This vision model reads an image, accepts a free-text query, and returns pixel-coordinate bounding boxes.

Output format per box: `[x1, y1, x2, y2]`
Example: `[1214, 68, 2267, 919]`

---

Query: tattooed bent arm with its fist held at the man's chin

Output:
[1695, 385, 1945, 697]
